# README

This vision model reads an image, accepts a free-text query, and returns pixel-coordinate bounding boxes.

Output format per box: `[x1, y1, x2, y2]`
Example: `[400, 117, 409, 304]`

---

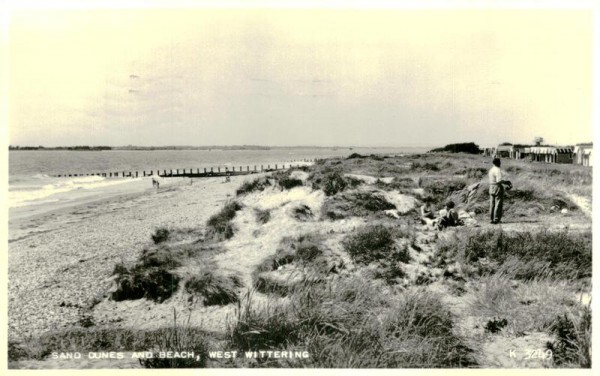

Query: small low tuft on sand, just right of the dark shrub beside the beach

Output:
[185, 270, 242, 306]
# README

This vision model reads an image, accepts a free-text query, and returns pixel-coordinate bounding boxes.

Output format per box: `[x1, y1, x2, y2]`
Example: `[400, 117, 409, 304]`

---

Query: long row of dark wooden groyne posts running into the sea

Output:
[54, 159, 316, 178]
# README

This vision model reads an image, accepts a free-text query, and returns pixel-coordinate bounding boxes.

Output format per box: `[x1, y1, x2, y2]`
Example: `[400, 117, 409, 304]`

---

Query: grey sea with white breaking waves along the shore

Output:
[8, 147, 428, 208]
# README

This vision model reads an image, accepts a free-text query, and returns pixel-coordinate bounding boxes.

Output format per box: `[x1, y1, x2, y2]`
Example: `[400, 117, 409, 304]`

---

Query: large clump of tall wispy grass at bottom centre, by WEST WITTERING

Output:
[227, 278, 473, 368]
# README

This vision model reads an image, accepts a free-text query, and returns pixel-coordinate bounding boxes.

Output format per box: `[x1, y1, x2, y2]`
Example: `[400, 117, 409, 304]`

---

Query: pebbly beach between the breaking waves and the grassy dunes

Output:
[8, 177, 245, 340]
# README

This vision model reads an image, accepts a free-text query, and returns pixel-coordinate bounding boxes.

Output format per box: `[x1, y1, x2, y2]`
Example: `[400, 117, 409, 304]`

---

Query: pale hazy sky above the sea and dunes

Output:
[8, 9, 593, 146]
